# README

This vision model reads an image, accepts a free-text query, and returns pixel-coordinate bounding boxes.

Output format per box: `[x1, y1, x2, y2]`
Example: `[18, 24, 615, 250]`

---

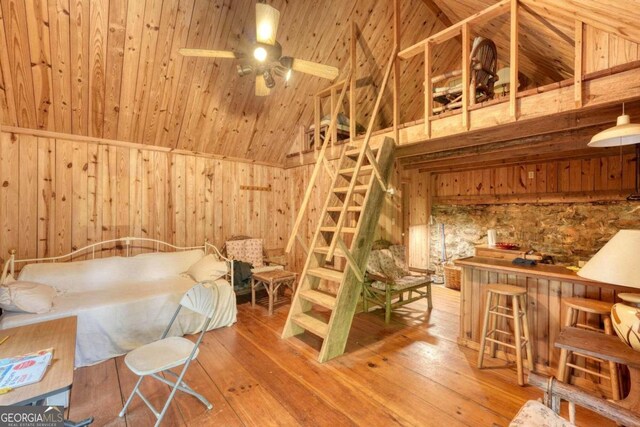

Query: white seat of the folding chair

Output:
[124, 337, 198, 376]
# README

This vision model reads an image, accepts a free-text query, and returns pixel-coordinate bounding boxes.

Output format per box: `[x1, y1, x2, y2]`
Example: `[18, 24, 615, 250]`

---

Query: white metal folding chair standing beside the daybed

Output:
[119, 282, 219, 426]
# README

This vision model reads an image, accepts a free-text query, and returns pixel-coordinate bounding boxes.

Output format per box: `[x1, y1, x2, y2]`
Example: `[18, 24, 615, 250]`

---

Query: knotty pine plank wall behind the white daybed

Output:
[0, 133, 289, 264]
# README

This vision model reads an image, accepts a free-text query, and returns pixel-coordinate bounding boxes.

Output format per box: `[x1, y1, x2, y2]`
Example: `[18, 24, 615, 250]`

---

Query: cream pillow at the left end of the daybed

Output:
[0, 282, 56, 314]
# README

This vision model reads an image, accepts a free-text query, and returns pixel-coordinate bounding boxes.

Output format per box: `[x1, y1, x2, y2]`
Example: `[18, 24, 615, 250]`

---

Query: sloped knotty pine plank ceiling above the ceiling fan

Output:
[0, 0, 638, 163]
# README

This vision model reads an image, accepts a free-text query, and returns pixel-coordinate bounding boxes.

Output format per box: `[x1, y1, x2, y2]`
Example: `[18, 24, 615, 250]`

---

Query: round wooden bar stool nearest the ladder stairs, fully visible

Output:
[478, 284, 533, 386]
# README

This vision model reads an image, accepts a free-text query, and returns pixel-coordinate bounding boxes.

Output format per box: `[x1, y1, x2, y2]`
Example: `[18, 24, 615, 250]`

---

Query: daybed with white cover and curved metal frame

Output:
[0, 237, 237, 367]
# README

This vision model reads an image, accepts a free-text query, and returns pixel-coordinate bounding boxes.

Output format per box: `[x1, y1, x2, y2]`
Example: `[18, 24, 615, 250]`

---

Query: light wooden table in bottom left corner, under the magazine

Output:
[0, 316, 77, 406]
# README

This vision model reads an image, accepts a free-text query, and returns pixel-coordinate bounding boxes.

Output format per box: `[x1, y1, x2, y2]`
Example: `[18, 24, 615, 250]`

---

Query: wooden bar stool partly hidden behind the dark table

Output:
[558, 298, 620, 400]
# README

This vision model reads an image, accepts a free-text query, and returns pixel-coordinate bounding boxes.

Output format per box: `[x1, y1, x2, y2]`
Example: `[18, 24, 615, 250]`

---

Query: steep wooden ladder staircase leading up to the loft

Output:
[282, 138, 395, 362]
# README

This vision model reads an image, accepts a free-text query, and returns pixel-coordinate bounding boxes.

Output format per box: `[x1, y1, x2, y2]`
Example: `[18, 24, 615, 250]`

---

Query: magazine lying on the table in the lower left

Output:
[0, 348, 53, 389]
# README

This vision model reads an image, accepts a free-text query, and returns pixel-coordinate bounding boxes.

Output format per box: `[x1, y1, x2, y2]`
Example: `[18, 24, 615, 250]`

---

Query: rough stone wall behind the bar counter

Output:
[430, 202, 640, 267]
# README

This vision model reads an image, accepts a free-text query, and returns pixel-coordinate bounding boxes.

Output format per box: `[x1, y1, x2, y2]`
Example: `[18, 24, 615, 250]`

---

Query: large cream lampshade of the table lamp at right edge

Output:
[578, 230, 640, 289]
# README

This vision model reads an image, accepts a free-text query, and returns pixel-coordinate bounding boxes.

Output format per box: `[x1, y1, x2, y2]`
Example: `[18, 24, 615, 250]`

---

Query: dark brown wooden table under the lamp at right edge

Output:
[556, 328, 640, 413]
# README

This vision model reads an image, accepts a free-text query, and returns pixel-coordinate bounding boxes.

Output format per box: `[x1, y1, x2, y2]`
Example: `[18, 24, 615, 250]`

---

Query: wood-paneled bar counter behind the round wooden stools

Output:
[455, 257, 637, 374]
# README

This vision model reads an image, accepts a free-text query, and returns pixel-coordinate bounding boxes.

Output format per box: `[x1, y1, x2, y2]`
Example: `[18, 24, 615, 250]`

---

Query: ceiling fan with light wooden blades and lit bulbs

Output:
[178, 1, 339, 96]
